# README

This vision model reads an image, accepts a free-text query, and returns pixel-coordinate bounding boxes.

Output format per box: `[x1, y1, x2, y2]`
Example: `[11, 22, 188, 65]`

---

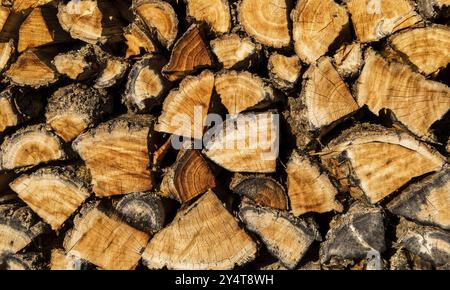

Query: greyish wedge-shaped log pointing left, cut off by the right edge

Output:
[388, 166, 450, 230]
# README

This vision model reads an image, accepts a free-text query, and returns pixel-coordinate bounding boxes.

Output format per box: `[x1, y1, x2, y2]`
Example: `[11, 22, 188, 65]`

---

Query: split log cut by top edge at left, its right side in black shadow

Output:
[58, 0, 122, 44]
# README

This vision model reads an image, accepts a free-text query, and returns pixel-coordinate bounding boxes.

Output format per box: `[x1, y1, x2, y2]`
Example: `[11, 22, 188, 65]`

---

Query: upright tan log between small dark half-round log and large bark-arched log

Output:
[286, 152, 343, 216]
